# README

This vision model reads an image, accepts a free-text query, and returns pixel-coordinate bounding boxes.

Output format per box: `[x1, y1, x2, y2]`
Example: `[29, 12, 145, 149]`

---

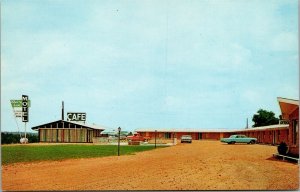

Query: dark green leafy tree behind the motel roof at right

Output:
[252, 109, 279, 127]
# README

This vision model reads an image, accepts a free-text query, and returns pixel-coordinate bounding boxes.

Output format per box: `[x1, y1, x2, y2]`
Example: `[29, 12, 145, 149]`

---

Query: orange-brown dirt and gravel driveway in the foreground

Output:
[2, 141, 299, 190]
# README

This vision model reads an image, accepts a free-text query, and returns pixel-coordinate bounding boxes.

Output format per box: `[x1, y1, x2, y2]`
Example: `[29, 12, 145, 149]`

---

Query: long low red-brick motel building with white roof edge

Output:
[135, 97, 299, 156]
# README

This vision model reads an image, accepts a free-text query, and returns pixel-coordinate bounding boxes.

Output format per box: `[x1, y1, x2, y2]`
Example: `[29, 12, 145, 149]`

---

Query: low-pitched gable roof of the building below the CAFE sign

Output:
[31, 120, 105, 130]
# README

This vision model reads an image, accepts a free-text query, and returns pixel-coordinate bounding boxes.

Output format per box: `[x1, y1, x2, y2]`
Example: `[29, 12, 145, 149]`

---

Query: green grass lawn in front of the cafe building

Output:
[1, 145, 164, 165]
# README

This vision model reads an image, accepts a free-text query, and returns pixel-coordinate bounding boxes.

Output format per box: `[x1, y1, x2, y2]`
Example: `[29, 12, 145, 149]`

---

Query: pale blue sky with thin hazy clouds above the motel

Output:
[1, 0, 299, 131]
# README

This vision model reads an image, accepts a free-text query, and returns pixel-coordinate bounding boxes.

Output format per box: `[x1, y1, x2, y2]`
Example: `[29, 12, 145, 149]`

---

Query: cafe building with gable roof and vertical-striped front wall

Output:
[31, 120, 104, 143]
